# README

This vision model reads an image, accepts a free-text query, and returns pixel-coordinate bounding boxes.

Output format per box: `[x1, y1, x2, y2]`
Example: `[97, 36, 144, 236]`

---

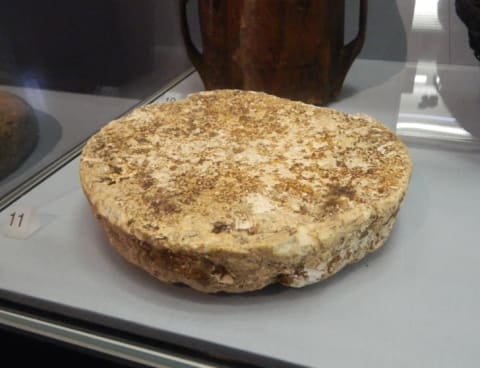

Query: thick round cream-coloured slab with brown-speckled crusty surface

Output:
[80, 90, 411, 292]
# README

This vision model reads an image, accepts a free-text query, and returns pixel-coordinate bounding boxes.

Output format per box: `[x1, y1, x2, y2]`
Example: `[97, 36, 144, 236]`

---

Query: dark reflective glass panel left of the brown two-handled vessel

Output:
[0, 0, 190, 199]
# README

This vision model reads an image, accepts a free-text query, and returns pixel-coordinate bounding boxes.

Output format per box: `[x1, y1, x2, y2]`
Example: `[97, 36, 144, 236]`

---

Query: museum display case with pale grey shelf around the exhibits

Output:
[0, 0, 480, 367]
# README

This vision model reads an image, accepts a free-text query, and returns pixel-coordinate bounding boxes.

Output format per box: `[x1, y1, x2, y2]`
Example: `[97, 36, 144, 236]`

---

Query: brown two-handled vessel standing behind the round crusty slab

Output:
[180, 0, 367, 104]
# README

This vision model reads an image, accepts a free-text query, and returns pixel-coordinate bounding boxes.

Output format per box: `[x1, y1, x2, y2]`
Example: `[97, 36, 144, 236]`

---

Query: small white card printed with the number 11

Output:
[0, 207, 41, 239]
